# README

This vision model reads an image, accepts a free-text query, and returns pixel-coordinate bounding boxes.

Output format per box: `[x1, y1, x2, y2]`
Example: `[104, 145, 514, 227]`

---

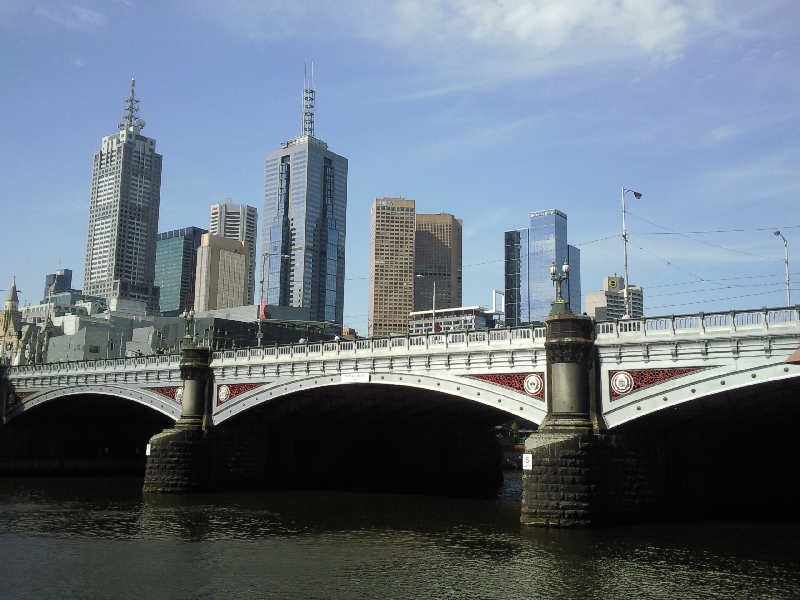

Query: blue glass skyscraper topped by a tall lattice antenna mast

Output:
[259, 69, 347, 325]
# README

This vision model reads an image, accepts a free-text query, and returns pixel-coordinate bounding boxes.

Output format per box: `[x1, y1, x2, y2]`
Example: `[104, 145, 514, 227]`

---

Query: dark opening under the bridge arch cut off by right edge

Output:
[608, 378, 800, 521]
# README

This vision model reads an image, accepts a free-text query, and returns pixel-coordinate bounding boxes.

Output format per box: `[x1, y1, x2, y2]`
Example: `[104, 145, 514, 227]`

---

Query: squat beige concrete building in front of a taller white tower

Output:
[194, 233, 250, 317]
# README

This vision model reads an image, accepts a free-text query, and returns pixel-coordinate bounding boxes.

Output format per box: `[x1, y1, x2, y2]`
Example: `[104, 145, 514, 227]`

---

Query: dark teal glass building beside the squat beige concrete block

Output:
[155, 227, 208, 317]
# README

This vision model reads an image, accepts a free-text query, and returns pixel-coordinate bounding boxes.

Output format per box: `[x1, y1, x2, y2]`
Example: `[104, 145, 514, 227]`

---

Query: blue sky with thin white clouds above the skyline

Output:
[0, 0, 800, 332]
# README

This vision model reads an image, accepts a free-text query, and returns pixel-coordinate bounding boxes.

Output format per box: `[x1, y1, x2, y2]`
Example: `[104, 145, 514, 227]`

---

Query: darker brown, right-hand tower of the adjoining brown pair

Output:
[414, 213, 462, 311]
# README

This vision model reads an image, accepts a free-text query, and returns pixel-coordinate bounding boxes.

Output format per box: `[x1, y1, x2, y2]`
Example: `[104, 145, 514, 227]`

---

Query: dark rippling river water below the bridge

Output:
[0, 472, 800, 600]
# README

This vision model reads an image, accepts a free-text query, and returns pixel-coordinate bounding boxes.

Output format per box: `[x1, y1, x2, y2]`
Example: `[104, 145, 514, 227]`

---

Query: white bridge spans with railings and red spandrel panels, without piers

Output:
[2, 308, 800, 429]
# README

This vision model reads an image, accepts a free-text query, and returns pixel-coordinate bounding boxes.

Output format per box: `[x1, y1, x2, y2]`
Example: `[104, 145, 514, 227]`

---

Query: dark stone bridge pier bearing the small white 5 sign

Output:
[520, 310, 664, 527]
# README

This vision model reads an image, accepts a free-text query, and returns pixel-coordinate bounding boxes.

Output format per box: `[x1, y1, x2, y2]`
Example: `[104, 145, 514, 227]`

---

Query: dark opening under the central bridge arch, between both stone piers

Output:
[218, 384, 535, 496]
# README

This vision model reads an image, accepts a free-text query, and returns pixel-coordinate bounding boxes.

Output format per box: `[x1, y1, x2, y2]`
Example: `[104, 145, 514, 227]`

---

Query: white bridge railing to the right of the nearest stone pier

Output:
[596, 307, 800, 343]
